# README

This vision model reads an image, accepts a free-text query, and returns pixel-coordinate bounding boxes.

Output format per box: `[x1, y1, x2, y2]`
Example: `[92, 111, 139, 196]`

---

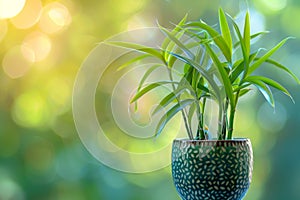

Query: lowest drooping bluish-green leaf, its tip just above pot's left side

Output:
[155, 99, 195, 137]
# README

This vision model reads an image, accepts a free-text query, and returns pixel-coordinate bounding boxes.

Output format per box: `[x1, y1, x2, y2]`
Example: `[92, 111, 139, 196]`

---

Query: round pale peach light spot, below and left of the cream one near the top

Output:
[22, 32, 52, 62]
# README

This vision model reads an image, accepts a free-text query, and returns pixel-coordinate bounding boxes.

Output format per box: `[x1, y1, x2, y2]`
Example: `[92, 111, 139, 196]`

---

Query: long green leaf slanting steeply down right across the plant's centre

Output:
[205, 44, 235, 107]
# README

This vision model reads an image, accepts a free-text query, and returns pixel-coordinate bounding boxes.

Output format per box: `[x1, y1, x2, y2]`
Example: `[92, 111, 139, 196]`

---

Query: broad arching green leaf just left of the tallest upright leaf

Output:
[185, 21, 231, 62]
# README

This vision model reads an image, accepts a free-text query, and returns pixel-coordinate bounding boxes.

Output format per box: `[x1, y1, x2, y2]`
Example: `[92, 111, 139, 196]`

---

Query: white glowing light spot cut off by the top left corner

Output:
[0, 0, 26, 19]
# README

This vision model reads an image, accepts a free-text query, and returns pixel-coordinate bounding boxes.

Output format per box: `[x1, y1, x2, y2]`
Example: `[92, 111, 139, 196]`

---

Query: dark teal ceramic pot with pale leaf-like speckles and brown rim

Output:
[172, 139, 253, 200]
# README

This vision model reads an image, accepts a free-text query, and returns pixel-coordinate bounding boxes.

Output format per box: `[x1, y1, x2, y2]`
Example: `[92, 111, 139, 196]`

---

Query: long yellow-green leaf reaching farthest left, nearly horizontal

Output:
[105, 41, 164, 61]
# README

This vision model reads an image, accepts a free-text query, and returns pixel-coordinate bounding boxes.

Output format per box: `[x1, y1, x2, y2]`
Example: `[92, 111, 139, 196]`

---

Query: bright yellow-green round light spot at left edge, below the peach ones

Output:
[12, 92, 51, 127]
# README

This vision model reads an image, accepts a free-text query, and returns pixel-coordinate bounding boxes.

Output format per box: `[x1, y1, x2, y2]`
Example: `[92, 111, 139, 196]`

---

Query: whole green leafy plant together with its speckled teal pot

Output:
[108, 8, 300, 200]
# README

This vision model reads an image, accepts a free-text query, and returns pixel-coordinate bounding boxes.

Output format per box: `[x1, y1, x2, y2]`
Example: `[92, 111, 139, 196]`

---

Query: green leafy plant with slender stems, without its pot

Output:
[108, 8, 300, 140]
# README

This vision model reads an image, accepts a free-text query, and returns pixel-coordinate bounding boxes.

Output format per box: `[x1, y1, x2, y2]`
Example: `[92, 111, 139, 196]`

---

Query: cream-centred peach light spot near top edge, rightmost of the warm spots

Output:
[39, 2, 72, 34]
